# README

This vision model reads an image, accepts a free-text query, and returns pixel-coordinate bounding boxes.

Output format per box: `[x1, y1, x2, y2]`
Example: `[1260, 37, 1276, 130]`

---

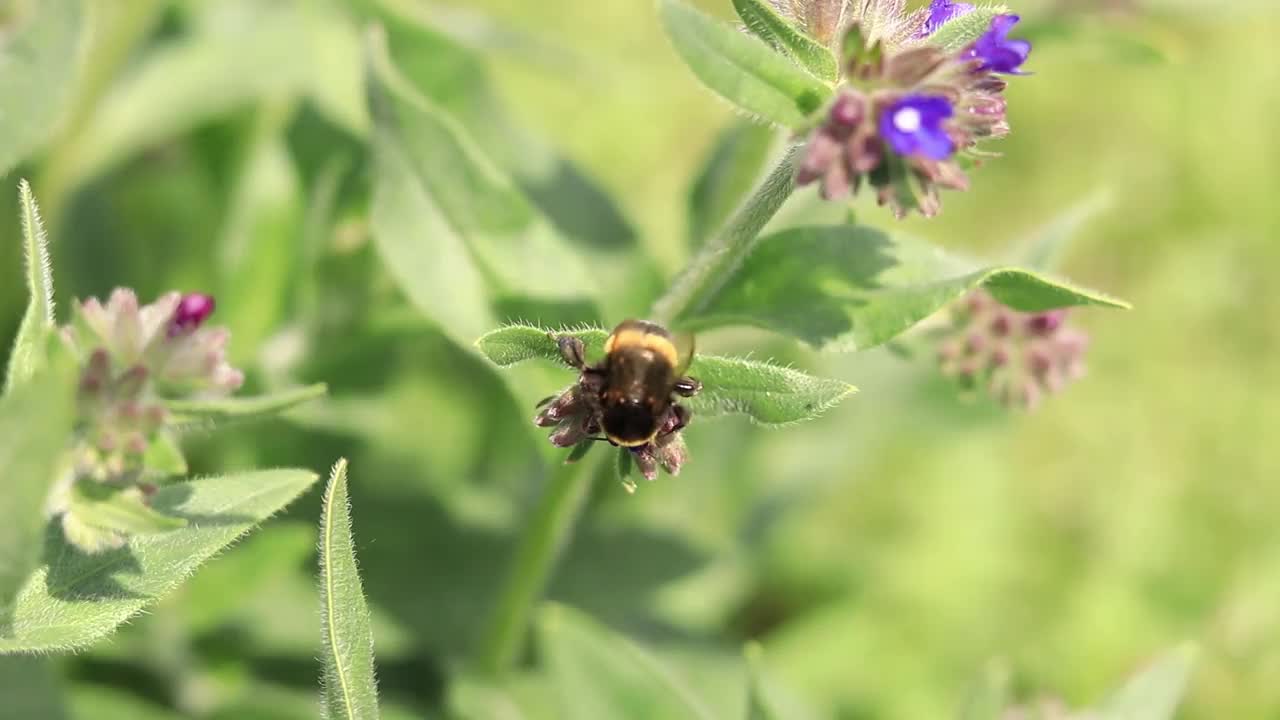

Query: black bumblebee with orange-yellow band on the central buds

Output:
[556, 320, 703, 447]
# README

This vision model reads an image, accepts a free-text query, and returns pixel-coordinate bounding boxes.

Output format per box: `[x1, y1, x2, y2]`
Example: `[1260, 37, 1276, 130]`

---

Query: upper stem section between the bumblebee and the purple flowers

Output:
[650, 146, 800, 324]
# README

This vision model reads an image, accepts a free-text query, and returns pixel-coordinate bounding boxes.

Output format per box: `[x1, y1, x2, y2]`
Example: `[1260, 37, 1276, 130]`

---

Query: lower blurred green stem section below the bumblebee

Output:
[476, 453, 598, 674]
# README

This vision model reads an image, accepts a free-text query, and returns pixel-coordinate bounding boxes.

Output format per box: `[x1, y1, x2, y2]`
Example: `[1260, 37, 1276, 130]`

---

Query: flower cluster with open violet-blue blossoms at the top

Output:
[782, 0, 1030, 217]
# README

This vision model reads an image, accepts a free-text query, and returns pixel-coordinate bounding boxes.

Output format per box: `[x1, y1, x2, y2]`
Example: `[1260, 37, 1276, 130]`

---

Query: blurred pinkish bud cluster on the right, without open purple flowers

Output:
[937, 290, 1089, 410]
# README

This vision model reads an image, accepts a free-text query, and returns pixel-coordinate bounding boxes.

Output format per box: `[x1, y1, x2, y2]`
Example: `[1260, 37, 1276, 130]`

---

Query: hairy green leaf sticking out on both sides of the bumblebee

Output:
[476, 325, 855, 425]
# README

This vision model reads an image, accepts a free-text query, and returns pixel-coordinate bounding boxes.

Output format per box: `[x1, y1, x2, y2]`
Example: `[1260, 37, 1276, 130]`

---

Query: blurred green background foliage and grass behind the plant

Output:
[0, 0, 1280, 720]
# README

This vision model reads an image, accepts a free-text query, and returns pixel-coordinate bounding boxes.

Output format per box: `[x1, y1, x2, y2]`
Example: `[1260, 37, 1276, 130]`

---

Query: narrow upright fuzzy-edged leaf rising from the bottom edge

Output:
[320, 460, 378, 720]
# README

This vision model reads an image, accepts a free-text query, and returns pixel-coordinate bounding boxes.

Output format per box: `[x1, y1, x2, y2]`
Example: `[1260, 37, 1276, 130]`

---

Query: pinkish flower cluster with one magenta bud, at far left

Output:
[52, 288, 244, 552]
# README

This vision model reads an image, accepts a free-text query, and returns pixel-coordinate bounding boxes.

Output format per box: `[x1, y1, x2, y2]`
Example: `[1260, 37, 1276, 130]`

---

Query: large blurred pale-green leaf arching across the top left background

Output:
[51, 3, 369, 188]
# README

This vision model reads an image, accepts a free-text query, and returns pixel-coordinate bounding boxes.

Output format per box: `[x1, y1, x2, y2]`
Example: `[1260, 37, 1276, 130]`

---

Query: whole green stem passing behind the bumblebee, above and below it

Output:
[476, 142, 799, 675]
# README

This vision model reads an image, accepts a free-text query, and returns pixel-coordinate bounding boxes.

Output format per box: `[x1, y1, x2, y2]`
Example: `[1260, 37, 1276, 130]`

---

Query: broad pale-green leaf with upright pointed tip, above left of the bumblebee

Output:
[369, 31, 594, 338]
